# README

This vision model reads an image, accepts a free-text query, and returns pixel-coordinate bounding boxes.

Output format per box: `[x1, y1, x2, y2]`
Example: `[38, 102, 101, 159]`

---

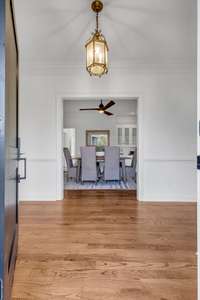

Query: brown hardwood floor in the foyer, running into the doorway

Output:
[13, 191, 197, 300]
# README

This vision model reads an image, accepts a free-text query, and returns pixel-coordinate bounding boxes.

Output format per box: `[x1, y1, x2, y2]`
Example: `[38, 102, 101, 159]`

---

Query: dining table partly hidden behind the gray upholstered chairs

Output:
[72, 155, 132, 180]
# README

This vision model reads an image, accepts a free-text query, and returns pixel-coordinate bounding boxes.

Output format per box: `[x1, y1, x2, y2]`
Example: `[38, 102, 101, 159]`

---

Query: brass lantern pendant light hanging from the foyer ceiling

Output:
[85, 0, 108, 77]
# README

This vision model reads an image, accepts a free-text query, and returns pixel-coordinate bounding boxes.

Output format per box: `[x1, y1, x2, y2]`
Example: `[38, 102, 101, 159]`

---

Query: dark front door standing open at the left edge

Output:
[0, 0, 19, 300]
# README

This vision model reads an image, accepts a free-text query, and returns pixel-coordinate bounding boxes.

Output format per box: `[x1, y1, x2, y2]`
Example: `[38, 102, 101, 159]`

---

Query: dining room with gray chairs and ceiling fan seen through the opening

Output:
[63, 98, 137, 191]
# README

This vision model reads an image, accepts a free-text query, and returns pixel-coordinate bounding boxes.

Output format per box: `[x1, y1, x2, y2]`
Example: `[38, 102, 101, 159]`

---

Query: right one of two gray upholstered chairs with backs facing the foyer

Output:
[104, 146, 121, 180]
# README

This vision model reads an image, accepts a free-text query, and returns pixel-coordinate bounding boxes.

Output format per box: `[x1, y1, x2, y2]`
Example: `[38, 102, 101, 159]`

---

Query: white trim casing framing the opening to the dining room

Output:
[56, 93, 144, 201]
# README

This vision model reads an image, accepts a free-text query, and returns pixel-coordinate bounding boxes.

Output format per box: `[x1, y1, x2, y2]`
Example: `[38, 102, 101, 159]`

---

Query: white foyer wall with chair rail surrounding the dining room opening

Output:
[20, 65, 197, 201]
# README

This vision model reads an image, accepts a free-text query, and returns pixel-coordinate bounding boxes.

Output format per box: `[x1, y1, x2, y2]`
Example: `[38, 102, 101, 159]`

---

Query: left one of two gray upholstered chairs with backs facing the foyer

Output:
[80, 147, 97, 182]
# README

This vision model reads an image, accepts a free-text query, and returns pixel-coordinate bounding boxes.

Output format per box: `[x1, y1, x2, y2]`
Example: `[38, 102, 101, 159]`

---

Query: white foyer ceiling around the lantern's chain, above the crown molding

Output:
[14, 0, 197, 64]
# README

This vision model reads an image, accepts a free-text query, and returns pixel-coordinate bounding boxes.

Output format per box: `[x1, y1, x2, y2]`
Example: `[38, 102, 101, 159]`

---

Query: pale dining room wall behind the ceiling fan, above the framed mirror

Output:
[63, 99, 137, 154]
